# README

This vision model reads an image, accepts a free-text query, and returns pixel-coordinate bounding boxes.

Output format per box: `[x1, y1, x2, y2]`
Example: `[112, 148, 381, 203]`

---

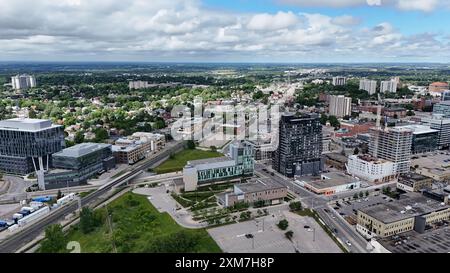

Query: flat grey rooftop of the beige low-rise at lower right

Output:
[359, 193, 450, 224]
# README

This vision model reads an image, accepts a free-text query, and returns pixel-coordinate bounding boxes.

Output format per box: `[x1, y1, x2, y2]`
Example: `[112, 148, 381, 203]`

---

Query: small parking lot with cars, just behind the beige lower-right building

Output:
[330, 194, 392, 219]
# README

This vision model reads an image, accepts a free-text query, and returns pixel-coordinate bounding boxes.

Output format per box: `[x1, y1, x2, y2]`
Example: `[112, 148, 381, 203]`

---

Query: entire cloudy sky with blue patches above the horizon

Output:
[0, 0, 450, 63]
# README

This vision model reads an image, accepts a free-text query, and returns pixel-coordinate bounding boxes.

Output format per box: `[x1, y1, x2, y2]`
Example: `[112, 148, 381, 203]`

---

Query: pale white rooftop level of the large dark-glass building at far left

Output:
[0, 118, 61, 132]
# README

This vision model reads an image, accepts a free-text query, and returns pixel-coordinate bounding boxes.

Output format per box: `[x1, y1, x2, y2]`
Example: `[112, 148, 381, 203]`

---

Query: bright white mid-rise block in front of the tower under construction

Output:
[346, 155, 396, 183]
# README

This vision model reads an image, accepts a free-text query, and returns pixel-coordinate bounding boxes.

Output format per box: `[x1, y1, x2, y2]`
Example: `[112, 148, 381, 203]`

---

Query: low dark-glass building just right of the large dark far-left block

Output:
[45, 143, 115, 190]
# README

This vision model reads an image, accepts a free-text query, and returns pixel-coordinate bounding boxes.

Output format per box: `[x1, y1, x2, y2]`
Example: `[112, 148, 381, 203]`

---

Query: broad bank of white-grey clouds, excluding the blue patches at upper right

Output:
[0, 0, 450, 62]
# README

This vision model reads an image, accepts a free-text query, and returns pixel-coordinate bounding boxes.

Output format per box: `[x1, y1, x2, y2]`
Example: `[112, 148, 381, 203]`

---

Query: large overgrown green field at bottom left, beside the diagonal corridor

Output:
[66, 193, 221, 253]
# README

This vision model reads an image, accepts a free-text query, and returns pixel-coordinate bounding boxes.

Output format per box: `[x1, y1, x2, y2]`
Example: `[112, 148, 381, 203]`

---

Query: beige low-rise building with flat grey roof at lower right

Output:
[356, 193, 450, 238]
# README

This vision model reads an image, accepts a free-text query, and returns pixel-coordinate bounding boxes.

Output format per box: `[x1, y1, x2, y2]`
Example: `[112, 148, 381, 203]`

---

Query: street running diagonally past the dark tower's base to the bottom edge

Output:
[255, 163, 367, 253]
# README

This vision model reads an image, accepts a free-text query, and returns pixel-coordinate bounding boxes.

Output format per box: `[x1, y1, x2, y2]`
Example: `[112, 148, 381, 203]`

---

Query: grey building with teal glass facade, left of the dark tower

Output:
[183, 142, 254, 191]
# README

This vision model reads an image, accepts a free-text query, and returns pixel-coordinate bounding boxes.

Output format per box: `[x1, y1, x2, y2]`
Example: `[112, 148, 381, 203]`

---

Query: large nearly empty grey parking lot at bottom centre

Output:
[208, 211, 342, 253]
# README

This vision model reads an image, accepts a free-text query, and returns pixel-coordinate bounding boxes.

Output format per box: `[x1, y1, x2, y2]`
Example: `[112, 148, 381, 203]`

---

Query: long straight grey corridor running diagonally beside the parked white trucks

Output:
[0, 142, 185, 253]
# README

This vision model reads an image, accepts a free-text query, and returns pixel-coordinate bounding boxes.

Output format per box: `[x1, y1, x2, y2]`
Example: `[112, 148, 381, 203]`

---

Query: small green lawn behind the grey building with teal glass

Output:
[154, 149, 224, 174]
